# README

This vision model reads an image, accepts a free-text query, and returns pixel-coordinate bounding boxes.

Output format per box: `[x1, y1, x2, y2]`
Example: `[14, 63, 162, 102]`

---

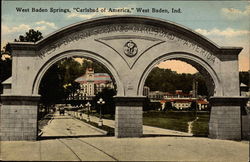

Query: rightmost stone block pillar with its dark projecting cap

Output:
[209, 97, 248, 140]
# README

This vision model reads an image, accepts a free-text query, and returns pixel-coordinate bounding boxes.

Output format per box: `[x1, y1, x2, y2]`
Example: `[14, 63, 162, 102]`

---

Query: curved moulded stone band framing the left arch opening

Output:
[32, 50, 125, 96]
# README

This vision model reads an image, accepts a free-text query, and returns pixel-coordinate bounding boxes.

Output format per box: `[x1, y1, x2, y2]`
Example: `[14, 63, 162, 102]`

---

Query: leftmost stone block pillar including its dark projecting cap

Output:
[0, 95, 40, 141]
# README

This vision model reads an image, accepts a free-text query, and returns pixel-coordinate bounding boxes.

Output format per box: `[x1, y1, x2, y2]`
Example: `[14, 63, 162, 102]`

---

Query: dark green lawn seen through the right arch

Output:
[143, 111, 209, 136]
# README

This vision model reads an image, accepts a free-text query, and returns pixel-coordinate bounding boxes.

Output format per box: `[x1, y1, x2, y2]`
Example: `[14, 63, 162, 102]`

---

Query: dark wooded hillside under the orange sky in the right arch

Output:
[145, 67, 208, 95]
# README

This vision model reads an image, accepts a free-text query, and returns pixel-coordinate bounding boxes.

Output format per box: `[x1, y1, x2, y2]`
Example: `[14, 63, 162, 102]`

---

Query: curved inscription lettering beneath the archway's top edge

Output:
[39, 24, 216, 63]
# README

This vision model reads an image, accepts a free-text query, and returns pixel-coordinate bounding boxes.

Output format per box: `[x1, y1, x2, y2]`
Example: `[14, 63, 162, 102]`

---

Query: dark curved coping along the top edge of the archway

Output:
[10, 15, 243, 55]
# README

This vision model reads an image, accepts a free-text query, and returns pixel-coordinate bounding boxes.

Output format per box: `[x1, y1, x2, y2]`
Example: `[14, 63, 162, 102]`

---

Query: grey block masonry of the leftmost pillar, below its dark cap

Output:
[0, 105, 37, 141]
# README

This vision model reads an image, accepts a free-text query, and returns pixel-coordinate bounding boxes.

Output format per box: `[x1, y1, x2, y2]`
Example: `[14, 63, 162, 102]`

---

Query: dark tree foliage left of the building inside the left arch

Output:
[39, 58, 83, 105]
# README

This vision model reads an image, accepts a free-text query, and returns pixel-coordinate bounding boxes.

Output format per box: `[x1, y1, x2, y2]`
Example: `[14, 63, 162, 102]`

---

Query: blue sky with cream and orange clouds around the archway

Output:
[1, 1, 250, 73]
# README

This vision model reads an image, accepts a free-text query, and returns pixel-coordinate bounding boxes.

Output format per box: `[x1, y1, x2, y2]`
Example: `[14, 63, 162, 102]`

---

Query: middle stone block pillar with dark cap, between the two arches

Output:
[115, 96, 145, 138]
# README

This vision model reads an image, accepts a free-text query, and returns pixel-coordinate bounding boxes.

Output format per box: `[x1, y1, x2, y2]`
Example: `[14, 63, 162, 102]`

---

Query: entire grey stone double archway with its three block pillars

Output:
[1, 16, 248, 140]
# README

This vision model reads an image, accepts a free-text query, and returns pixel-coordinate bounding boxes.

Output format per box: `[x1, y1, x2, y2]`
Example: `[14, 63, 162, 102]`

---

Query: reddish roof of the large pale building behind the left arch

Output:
[75, 73, 112, 84]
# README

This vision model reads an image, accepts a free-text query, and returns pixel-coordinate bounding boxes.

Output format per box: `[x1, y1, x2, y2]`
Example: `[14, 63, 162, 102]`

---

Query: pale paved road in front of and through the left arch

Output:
[1, 112, 249, 162]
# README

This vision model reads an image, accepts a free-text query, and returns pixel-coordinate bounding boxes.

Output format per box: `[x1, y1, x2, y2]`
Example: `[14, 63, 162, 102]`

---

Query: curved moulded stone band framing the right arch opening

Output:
[137, 52, 223, 96]
